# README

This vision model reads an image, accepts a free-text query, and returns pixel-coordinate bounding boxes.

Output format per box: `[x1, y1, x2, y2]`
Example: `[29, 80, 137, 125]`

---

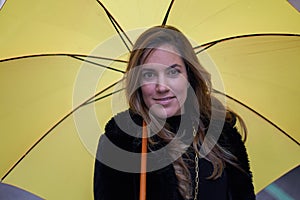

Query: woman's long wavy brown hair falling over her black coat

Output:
[125, 25, 246, 199]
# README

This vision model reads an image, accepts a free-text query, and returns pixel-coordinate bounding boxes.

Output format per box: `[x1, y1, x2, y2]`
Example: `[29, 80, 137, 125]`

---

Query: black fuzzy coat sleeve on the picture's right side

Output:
[225, 125, 255, 200]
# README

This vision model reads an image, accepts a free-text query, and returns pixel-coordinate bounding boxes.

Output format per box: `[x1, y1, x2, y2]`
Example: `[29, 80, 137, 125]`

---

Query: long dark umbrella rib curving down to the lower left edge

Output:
[0, 79, 122, 181]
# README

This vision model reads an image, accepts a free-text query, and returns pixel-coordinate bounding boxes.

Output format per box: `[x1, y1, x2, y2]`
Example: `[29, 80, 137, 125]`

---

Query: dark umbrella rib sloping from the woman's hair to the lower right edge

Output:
[213, 89, 300, 145]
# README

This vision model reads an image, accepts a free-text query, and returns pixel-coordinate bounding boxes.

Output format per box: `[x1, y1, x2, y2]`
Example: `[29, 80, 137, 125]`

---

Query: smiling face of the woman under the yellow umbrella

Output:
[140, 45, 189, 118]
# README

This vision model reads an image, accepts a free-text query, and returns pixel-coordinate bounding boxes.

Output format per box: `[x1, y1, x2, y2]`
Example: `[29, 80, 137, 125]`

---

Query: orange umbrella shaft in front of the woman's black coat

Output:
[140, 122, 148, 200]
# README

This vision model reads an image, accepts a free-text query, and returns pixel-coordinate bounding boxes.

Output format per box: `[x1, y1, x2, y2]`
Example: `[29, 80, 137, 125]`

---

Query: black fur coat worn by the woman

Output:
[94, 111, 255, 200]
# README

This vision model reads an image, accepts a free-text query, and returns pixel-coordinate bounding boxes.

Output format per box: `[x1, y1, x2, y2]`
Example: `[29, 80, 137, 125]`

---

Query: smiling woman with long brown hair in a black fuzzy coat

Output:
[94, 26, 255, 200]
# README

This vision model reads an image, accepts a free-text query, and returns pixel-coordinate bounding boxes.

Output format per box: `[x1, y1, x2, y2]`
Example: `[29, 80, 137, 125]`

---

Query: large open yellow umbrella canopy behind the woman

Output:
[0, 0, 300, 199]
